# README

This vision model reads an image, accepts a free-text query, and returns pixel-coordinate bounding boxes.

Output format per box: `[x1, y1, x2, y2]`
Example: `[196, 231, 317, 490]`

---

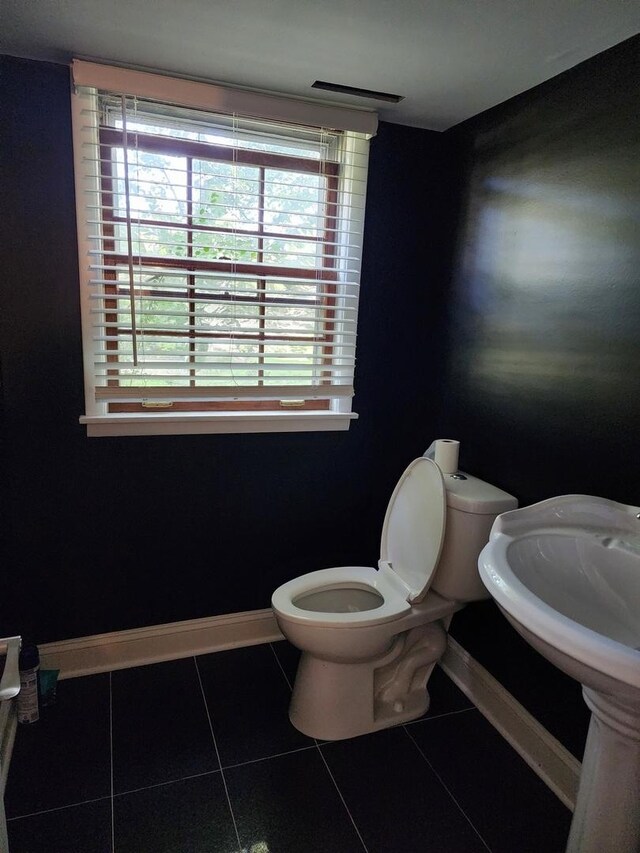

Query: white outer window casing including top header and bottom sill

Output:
[72, 60, 377, 436]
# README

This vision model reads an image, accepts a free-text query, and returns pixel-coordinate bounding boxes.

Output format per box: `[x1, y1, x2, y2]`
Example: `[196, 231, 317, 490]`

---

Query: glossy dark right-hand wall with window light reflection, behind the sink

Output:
[443, 37, 640, 753]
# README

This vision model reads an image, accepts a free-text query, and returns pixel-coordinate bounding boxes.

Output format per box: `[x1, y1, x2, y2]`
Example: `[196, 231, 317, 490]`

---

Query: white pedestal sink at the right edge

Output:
[478, 495, 640, 853]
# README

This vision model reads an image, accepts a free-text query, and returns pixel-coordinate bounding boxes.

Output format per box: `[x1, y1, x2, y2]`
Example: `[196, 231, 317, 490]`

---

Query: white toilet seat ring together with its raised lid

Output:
[272, 457, 446, 628]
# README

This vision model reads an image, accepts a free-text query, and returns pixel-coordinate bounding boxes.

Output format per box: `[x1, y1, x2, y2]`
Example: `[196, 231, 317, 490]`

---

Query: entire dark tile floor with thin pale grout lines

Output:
[6, 642, 571, 853]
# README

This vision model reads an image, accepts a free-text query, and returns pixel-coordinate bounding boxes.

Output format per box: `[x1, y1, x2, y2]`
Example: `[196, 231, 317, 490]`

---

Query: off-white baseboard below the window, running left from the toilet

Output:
[40, 608, 283, 678]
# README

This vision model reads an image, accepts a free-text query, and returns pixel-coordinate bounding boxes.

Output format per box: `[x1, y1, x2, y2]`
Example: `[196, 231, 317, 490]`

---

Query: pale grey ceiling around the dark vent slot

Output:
[0, 0, 640, 130]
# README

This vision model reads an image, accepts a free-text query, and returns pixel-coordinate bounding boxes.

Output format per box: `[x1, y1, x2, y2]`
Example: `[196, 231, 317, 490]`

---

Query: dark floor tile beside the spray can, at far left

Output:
[5, 674, 111, 817]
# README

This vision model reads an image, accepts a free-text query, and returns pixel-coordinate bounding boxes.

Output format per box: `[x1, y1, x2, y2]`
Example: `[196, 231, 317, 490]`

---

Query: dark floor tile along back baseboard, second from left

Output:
[112, 658, 219, 793]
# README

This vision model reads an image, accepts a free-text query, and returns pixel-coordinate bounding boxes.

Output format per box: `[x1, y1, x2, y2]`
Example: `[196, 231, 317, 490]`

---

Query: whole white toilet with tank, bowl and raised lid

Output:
[271, 457, 518, 740]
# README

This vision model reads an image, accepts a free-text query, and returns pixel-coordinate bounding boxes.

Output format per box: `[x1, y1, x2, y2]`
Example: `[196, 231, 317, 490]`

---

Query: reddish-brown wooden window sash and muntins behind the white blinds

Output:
[99, 115, 339, 413]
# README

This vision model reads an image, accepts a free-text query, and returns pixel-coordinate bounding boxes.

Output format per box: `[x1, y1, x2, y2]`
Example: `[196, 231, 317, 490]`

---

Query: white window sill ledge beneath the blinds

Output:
[80, 412, 358, 437]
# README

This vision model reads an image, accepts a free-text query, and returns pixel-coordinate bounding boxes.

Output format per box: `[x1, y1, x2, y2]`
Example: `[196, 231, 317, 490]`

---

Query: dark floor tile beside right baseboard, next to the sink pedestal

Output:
[406, 711, 571, 853]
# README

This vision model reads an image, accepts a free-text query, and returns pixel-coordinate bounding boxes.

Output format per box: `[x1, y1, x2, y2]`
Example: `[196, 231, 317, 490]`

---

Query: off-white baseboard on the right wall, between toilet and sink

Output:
[440, 637, 581, 811]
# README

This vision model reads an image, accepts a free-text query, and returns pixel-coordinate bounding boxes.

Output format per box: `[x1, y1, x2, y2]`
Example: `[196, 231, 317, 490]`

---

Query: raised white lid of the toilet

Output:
[380, 456, 447, 601]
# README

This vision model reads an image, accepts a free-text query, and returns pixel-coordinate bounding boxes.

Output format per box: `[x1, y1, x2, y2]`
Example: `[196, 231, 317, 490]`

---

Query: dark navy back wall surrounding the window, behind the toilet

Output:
[0, 58, 450, 642]
